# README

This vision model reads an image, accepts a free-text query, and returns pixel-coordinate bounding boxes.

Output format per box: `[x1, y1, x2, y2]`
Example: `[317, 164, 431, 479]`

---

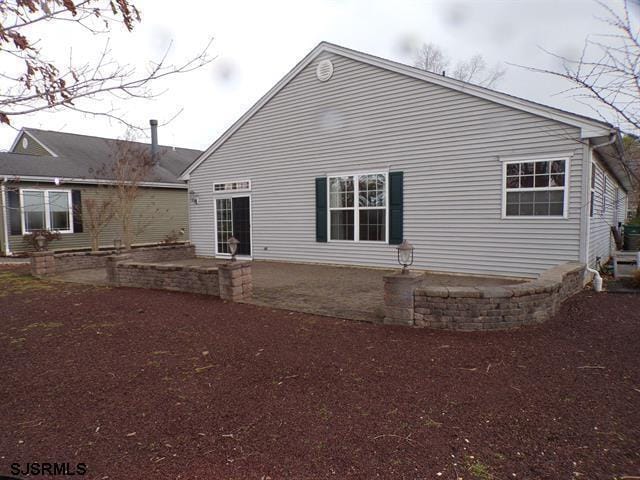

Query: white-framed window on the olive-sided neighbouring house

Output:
[20, 190, 73, 233]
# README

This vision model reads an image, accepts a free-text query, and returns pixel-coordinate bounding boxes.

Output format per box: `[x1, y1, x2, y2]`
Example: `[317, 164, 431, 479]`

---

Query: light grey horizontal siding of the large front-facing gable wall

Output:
[190, 52, 583, 277]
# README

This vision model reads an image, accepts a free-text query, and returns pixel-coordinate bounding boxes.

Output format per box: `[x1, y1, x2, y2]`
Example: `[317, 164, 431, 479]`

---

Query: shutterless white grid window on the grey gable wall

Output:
[504, 159, 568, 217]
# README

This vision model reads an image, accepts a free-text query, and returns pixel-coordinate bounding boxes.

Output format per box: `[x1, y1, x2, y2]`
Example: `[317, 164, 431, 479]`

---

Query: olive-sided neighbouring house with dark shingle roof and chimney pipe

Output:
[0, 125, 201, 255]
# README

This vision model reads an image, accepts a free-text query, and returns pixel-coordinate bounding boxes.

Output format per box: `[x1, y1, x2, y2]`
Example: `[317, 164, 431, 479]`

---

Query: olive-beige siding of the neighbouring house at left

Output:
[9, 182, 189, 253]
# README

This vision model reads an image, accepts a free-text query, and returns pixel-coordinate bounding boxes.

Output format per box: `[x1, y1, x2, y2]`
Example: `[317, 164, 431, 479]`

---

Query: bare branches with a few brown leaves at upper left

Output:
[0, 0, 213, 128]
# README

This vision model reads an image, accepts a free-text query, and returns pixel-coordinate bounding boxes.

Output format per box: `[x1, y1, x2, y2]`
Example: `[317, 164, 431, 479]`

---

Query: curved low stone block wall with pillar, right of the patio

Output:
[385, 262, 585, 331]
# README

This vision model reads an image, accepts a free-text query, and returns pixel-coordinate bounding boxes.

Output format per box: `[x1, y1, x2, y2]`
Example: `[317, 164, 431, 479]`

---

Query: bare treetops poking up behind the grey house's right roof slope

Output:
[414, 43, 506, 88]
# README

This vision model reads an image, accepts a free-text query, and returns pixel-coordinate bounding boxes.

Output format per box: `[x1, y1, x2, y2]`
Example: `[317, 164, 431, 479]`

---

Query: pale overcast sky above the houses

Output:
[0, 0, 637, 149]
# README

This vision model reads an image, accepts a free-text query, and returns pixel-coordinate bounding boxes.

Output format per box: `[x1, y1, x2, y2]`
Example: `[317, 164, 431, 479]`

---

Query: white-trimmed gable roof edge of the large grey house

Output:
[180, 42, 614, 180]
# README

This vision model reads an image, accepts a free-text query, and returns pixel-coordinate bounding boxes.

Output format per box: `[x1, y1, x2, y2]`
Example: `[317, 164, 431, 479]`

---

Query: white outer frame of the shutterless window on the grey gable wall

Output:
[500, 155, 571, 220]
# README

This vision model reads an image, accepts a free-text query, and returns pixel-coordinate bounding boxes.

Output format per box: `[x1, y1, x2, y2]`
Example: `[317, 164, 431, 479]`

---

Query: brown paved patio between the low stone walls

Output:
[53, 258, 514, 322]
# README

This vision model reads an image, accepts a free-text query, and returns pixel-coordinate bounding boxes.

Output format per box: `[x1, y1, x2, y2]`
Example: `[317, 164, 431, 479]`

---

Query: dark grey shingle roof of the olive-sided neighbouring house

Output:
[0, 128, 201, 186]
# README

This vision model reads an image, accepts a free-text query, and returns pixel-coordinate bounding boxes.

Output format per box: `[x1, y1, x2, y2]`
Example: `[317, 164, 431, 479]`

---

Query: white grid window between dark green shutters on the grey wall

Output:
[329, 173, 388, 242]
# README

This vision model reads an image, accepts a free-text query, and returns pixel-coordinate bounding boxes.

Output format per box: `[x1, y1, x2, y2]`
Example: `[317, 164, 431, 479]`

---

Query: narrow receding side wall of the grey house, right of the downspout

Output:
[587, 152, 627, 267]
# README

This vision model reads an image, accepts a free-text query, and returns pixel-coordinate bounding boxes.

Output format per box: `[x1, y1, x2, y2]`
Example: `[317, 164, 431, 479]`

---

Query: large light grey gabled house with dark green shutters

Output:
[181, 43, 630, 277]
